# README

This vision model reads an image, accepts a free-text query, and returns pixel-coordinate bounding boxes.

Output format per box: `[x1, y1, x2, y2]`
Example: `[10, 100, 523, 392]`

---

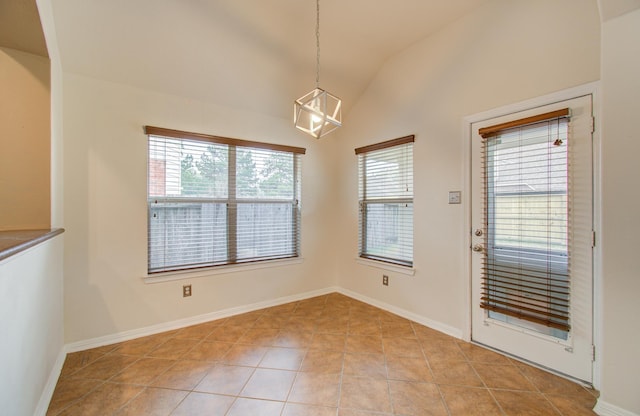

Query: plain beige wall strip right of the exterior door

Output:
[598, 9, 640, 415]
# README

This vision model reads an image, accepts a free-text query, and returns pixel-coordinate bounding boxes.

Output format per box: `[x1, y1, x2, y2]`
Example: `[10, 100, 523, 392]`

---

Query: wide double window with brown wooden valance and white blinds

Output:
[145, 126, 305, 274]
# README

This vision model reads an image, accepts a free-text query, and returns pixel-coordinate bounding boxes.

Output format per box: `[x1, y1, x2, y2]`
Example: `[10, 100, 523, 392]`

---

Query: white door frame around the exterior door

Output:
[461, 81, 602, 389]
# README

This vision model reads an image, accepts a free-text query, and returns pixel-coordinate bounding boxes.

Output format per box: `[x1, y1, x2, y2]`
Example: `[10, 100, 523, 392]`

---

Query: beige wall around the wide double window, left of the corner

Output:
[63, 73, 336, 343]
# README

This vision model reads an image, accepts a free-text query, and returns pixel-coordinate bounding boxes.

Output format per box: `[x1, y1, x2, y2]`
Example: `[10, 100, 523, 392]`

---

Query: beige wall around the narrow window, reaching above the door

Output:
[335, 0, 600, 336]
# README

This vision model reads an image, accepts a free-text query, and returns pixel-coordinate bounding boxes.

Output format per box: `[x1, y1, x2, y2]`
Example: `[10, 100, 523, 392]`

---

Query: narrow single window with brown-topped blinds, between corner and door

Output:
[356, 136, 414, 267]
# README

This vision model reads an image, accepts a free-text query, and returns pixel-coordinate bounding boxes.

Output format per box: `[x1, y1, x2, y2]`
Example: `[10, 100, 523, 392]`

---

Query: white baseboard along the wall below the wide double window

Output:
[65, 287, 339, 353]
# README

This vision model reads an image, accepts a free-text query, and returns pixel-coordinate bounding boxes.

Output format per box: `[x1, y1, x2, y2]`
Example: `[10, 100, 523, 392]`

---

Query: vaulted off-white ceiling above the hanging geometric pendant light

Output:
[52, 0, 487, 118]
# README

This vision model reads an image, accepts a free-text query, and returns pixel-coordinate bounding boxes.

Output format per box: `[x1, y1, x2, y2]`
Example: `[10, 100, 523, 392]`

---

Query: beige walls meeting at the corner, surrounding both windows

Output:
[57, 0, 600, 370]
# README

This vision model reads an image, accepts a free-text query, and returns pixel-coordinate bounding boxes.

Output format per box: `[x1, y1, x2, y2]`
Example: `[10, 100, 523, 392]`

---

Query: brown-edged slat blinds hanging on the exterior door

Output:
[480, 110, 570, 331]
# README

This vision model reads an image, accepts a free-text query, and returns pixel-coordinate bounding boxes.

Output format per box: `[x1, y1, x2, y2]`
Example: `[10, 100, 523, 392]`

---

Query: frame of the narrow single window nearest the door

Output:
[355, 135, 415, 270]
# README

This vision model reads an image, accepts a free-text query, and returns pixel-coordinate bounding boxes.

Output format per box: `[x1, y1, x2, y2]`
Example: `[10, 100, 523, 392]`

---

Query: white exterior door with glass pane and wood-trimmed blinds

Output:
[470, 95, 594, 383]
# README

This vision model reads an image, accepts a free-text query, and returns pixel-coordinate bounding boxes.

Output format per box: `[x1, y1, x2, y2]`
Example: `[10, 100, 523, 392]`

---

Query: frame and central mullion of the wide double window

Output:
[144, 126, 306, 280]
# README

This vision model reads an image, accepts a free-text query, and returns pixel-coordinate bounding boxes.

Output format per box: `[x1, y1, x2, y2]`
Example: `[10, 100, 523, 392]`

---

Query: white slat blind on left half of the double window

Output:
[148, 136, 228, 273]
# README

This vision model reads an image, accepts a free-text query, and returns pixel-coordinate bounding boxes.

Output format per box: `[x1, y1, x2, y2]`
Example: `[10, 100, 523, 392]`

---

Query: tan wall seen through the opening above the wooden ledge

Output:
[0, 48, 51, 230]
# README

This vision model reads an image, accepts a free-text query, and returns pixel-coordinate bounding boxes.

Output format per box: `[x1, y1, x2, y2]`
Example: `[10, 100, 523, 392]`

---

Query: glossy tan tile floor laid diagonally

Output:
[47, 293, 597, 416]
